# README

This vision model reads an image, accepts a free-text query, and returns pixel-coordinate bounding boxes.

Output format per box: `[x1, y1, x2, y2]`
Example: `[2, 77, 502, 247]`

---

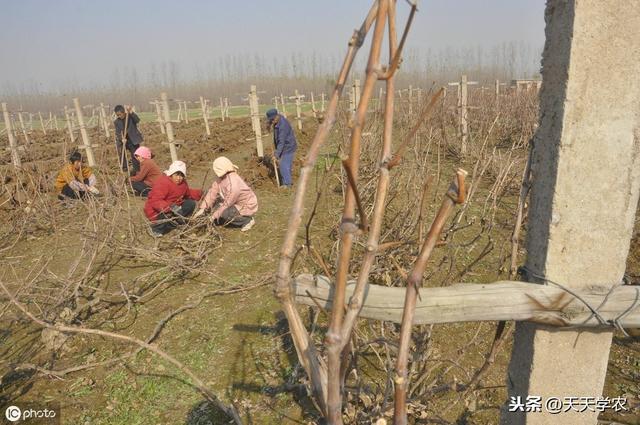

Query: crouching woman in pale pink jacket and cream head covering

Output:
[194, 156, 258, 232]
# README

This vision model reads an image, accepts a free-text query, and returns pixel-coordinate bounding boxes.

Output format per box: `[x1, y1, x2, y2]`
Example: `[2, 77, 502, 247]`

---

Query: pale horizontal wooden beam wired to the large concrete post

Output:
[293, 274, 640, 328]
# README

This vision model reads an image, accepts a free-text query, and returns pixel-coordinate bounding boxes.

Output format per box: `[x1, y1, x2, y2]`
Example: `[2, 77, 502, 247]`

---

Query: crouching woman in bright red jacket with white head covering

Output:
[144, 161, 202, 237]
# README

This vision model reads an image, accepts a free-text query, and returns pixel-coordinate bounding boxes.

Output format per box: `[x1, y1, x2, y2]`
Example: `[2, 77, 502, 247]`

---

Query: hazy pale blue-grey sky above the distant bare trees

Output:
[0, 0, 544, 89]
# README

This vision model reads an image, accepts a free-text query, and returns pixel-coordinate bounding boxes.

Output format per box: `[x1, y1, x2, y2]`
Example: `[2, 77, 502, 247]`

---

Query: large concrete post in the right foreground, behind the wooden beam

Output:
[501, 0, 640, 425]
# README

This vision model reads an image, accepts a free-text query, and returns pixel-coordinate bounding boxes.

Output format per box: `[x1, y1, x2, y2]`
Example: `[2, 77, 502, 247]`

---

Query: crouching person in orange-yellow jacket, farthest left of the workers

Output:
[55, 151, 100, 200]
